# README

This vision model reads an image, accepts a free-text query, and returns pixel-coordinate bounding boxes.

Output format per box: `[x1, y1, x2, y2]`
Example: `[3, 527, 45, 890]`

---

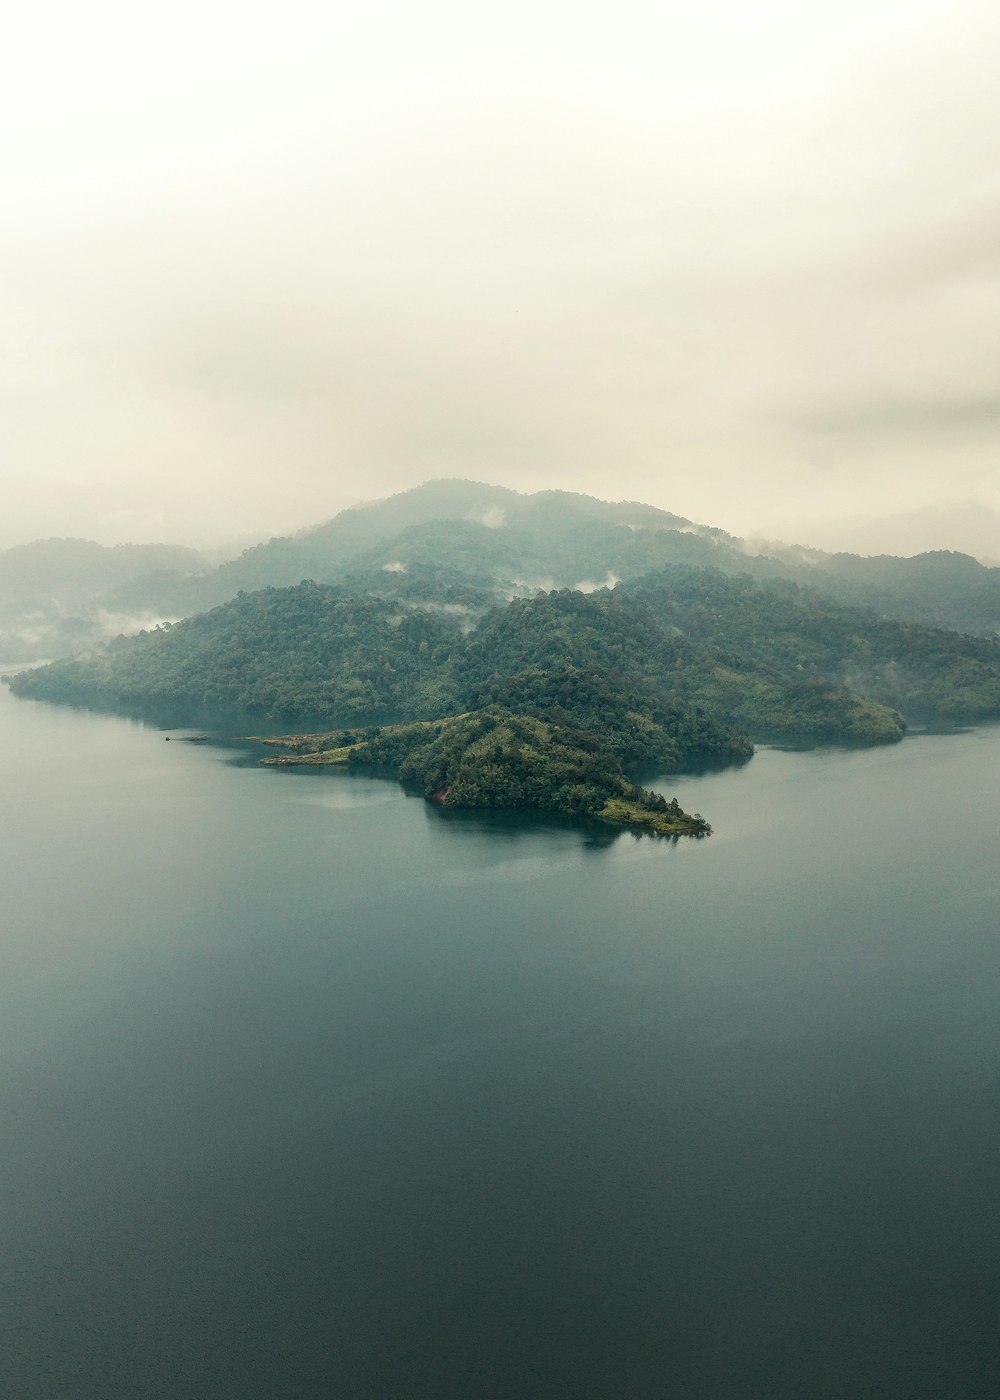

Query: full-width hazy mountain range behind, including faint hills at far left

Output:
[0, 480, 1000, 661]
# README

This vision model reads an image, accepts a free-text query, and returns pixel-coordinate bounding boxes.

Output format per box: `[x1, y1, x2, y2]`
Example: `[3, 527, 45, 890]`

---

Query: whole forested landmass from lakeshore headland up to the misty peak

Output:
[7, 483, 1000, 834]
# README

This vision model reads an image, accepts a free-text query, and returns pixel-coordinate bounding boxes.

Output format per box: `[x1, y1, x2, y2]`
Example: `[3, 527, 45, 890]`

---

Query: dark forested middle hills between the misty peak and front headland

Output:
[10, 567, 1000, 766]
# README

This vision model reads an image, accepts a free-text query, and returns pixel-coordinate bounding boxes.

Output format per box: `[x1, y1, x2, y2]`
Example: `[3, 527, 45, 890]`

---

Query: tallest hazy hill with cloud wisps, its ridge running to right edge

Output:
[165, 480, 1000, 633]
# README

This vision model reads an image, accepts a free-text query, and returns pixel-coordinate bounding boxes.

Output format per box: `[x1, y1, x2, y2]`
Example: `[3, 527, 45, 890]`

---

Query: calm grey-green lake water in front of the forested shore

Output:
[0, 689, 1000, 1400]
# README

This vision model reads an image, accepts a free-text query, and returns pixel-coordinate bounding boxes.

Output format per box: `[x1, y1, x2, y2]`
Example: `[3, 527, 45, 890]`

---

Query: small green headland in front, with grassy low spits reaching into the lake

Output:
[253, 706, 711, 837]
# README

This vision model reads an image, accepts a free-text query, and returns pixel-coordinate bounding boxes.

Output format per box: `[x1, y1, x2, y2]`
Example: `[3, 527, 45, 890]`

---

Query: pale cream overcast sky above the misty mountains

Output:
[0, 0, 1000, 556]
